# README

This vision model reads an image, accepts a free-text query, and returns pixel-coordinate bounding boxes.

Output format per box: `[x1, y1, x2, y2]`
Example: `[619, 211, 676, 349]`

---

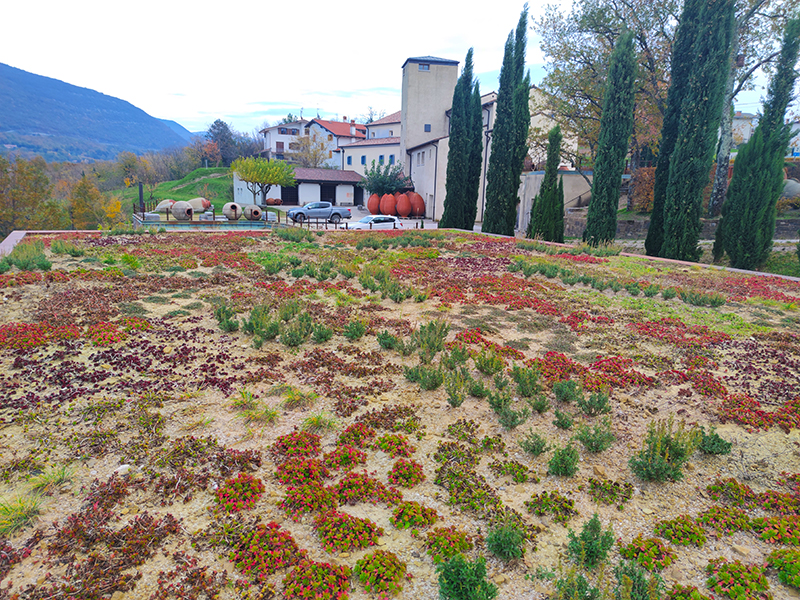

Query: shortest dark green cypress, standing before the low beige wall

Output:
[527, 125, 564, 242]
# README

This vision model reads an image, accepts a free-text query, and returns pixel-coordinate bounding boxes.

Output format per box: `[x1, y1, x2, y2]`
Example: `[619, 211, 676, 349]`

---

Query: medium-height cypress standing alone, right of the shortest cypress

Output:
[583, 31, 636, 246]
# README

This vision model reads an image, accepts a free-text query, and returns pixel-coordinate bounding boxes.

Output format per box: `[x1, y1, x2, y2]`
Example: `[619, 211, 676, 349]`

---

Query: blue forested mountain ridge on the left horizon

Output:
[0, 63, 191, 161]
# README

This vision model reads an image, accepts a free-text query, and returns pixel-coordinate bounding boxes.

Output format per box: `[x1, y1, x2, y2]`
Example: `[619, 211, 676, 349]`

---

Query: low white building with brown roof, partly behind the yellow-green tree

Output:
[233, 167, 364, 206]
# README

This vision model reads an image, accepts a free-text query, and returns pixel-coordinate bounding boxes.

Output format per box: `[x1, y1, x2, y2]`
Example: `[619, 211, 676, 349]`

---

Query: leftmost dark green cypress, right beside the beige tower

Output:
[439, 48, 483, 230]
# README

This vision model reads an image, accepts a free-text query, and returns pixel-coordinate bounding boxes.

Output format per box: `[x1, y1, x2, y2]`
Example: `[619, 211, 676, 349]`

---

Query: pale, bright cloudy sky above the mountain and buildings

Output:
[0, 0, 759, 133]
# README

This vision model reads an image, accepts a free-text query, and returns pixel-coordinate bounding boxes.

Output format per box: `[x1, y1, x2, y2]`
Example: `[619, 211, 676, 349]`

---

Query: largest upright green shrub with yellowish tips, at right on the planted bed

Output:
[628, 416, 702, 481]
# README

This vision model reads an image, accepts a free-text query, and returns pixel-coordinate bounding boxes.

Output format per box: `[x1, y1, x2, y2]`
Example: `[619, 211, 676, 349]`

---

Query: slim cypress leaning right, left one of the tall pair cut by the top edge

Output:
[644, 0, 705, 256]
